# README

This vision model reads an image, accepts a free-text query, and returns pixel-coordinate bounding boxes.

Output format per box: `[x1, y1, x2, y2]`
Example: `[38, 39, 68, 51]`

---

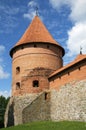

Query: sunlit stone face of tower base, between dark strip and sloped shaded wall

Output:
[14, 94, 39, 125]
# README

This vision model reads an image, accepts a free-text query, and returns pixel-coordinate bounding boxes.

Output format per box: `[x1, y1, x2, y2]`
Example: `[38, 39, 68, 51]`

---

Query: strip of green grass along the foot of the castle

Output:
[1, 121, 86, 130]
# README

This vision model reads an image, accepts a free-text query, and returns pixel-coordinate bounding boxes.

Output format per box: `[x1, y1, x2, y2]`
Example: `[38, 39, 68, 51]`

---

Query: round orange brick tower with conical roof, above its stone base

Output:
[10, 16, 65, 96]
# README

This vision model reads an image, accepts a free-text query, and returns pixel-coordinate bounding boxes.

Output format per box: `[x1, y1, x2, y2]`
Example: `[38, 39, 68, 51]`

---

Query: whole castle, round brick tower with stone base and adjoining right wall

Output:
[4, 16, 86, 127]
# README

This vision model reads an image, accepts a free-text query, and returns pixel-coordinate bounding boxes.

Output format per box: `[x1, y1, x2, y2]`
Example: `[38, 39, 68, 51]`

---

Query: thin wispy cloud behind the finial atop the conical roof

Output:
[23, 1, 38, 20]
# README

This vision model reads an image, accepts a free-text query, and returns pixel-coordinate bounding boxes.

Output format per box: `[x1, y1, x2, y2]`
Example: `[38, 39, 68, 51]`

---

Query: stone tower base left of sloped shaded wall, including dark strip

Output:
[4, 94, 39, 127]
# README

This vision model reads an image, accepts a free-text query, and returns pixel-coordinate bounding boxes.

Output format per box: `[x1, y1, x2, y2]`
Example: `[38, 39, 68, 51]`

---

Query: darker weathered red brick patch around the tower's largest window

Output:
[13, 68, 51, 95]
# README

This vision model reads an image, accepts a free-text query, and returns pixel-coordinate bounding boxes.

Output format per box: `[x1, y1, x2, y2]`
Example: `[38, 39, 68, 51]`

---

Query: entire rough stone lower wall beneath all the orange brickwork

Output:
[5, 80, 86, 127]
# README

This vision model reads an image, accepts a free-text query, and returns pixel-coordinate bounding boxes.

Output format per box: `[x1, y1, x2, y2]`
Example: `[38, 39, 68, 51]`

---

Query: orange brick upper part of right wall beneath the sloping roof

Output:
[49, 60, 86, 90]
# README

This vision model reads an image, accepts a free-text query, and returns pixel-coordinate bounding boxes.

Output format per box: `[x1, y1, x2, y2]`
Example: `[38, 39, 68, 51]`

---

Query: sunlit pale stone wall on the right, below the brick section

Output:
[51, 80, 86, 121]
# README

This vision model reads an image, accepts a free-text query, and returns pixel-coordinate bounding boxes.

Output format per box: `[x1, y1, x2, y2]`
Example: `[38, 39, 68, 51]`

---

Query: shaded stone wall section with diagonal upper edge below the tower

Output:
[22, 92, 50, 123]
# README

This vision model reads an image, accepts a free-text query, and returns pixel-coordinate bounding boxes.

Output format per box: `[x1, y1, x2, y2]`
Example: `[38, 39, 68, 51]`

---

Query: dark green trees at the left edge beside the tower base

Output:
[0, 96, 9, 128]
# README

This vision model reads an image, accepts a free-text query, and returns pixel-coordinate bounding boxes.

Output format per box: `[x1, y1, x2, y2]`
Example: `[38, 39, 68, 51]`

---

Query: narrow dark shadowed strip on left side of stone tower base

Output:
[7, 103, 14, 127]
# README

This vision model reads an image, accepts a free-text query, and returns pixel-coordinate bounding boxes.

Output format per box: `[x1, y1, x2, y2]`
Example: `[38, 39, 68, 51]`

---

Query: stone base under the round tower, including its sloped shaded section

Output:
[5, 92, 50, 127]
